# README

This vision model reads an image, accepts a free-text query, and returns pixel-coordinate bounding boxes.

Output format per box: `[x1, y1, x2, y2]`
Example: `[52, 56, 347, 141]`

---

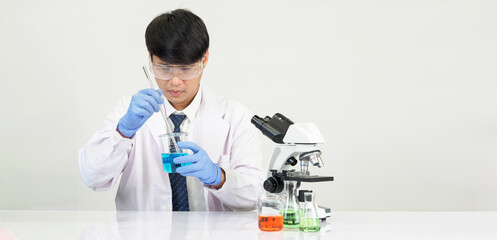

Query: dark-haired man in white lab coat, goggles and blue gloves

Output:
[79, 9, 263, 211]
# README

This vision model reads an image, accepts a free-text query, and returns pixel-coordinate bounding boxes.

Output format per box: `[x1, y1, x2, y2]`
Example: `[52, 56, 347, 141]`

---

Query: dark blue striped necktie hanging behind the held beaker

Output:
[169, 114, 190, 211]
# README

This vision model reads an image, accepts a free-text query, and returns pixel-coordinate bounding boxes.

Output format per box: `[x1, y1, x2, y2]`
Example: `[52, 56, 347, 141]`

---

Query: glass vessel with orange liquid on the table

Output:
[257, 193, 283, 232]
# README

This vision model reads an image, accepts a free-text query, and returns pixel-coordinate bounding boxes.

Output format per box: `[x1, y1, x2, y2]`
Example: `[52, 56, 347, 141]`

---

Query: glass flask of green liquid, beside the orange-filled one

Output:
[281, 181, 301, 228]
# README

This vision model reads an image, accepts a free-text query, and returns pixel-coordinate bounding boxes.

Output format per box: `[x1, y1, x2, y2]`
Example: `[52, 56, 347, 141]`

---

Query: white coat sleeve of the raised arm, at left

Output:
[78, 99, 133, 191]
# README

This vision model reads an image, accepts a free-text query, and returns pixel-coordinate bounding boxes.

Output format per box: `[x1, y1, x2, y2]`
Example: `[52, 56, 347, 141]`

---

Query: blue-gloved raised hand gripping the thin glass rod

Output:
[117, 88, 163, 137]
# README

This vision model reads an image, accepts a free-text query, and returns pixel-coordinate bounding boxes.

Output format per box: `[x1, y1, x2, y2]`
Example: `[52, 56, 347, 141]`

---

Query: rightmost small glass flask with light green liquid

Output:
[299, 192, 321, 232]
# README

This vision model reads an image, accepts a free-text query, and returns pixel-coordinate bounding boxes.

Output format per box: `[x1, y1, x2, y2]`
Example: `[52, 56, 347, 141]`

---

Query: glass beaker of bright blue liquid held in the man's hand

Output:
[159, 132, 192, 173]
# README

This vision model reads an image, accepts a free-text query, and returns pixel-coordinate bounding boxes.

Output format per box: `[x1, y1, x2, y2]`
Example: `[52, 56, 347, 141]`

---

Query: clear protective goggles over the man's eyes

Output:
[149, 58, 204, 80]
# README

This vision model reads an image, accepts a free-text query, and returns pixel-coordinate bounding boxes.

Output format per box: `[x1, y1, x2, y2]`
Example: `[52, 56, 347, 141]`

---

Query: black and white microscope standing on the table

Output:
[251, 113, 333, 220]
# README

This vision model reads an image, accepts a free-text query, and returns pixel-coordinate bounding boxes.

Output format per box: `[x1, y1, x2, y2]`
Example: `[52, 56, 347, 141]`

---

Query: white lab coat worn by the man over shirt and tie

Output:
[79, 87, 264, 211]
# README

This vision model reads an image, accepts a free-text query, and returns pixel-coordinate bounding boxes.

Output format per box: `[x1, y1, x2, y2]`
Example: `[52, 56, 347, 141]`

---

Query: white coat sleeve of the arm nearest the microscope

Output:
[208, 107, 264, 211]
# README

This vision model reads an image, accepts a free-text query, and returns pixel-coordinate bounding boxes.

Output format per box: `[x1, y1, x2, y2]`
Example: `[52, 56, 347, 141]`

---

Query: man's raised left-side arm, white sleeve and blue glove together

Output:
[79, 89, 162, 190]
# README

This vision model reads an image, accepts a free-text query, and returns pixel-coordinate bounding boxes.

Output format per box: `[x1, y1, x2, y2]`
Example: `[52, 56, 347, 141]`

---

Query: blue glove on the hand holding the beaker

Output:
[173, 142, 223, 185]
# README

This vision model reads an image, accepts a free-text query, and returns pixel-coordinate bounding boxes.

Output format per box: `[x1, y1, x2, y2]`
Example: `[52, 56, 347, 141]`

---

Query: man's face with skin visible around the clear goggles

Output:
[152, 51, 209, 110]
